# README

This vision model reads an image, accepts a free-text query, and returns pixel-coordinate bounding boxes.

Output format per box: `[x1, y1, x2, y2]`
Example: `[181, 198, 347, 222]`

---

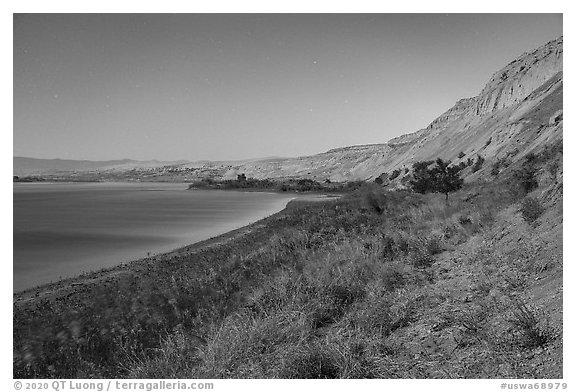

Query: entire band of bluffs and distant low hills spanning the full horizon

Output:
[14, 37, 563, 182]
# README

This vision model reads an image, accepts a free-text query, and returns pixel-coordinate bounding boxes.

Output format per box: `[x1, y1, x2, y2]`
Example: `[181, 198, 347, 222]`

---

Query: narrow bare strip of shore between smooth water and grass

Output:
[12, 193, 342, 306]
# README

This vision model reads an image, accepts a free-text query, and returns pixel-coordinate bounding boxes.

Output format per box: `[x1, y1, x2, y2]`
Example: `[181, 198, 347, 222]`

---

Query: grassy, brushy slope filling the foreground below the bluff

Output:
[14, 142, 562, 378]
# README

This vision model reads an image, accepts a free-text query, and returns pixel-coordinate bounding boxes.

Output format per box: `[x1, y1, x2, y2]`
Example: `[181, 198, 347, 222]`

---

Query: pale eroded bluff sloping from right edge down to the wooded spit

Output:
[204, 37, 563, 181]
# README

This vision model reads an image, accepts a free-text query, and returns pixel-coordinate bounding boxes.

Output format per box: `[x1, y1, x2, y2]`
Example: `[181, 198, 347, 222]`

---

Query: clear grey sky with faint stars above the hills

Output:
[13, 14, 562, 160]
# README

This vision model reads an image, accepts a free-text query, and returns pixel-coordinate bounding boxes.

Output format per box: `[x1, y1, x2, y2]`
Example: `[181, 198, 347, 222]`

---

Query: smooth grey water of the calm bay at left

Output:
[14, 183, 291, 291]
